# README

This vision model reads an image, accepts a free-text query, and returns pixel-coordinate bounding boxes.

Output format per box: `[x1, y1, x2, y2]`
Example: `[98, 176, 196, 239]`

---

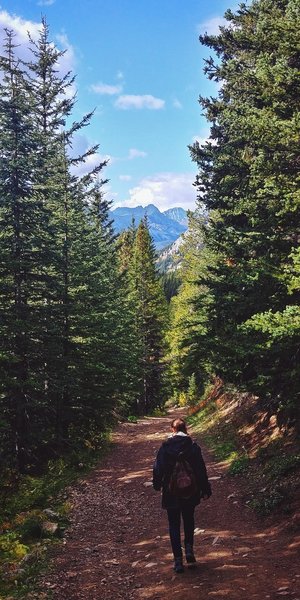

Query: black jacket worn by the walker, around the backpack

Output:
[153, 435, 211, 508]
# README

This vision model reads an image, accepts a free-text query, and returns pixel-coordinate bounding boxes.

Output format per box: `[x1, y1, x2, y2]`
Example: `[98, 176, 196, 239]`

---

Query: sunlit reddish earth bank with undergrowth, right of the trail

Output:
[189, 381, 300, 519]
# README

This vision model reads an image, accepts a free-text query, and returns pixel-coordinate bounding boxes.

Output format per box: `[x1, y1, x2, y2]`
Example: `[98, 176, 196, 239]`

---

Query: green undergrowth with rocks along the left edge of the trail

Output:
[0, 431, 111, 600]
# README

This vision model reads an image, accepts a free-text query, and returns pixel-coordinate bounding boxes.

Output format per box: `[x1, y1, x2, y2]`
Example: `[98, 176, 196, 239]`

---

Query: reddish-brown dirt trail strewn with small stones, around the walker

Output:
[39, 411, 300, 600]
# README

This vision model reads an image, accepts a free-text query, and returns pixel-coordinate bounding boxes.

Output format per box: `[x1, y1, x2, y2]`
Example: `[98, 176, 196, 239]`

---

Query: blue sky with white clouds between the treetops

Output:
[0, 0, 237, 210]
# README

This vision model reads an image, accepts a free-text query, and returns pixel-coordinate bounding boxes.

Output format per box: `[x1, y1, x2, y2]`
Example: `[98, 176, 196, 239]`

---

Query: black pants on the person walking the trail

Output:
[167, 505, 195, 558]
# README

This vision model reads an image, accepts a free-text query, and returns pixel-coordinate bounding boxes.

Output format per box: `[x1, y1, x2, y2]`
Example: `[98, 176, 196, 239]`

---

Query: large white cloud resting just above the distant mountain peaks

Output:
[118, 173, 197, 211]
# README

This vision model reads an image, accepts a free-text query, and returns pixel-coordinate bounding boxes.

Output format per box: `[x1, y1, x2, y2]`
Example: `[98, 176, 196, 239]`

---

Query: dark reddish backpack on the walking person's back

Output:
[169, 452, 198, 500]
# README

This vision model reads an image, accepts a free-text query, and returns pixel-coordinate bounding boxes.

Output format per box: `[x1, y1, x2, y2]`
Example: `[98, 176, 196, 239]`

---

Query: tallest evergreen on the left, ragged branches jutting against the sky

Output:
[27, 19, 106, 444]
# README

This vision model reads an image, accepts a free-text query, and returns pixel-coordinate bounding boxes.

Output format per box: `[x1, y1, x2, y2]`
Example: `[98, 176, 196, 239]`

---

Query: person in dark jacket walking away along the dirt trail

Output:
[153, 419, 212, 573]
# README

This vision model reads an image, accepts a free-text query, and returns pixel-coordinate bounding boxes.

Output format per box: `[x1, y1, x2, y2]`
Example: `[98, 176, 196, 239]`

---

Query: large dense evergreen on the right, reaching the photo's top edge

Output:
[191, 0, 300, 408]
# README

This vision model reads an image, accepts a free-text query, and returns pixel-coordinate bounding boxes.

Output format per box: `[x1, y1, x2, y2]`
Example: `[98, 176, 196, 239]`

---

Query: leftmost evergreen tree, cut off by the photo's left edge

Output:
[0, 31, 54, 472]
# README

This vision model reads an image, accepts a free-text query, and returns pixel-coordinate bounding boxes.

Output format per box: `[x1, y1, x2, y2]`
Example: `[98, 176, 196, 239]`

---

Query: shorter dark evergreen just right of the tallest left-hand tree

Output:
[70, 182, 126, 433]
